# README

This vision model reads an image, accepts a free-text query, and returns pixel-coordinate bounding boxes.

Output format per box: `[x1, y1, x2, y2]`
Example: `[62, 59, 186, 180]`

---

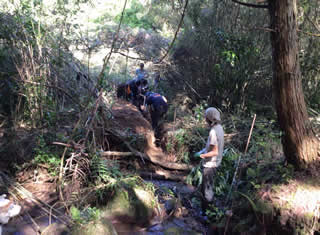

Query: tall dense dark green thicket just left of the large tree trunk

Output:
[168, 1, 272, 113]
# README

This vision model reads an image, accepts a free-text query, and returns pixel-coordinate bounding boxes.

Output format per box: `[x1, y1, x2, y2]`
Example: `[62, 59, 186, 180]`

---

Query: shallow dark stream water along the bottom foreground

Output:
[3, 180, 206, 235]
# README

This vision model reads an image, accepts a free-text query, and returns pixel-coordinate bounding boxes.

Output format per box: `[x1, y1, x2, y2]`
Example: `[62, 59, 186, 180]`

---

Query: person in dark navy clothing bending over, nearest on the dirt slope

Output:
[145, 92, 168, 130]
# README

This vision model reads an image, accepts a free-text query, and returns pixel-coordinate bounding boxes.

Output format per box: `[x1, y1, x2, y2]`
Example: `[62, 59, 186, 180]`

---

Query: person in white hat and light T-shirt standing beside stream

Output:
[195, 107, 224, 207]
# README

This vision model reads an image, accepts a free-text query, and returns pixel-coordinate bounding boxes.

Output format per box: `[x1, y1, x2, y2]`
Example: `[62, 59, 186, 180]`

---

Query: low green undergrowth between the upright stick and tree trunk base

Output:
[234, 120, 294, 195]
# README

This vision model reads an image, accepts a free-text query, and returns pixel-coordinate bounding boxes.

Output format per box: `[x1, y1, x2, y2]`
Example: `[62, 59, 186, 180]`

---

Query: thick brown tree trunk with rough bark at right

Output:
[268, 0, 319, 170]
